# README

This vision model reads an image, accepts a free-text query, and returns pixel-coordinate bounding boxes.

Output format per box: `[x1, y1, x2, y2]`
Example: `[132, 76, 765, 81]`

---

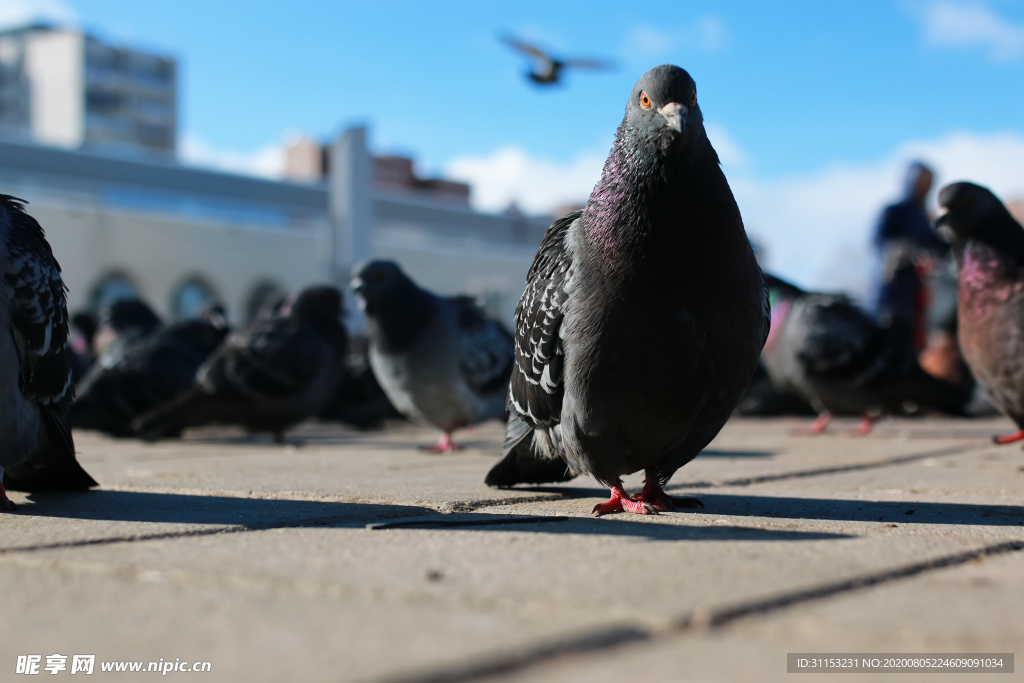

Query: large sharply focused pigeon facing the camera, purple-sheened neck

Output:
[485, 65, 769, 515]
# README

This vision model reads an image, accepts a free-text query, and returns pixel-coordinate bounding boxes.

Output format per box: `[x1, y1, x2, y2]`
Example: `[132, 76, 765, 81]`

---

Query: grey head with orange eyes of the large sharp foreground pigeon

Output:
[623, 65, 703, 150]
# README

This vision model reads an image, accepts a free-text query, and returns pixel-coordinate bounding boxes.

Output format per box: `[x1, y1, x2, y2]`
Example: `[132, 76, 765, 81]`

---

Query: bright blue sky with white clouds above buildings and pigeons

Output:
[0, 0, 1024, 287]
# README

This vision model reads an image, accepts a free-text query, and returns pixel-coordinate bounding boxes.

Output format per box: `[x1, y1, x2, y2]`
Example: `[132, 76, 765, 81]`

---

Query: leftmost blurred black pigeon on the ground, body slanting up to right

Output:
[71, 316, 229, 436]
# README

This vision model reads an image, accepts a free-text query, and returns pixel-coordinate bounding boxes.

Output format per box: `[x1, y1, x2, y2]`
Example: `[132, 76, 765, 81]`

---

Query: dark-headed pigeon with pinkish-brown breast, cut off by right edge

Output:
[936, 182, 1024, 443]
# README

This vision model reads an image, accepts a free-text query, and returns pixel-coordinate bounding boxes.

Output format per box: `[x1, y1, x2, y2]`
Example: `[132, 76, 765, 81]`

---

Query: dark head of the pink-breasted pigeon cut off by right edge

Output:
[935, 182, 1020, 242]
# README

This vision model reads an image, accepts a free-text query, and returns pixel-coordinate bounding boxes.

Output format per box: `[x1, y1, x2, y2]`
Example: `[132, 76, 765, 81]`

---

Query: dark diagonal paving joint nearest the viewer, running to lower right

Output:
[376, 541, 1024, 683]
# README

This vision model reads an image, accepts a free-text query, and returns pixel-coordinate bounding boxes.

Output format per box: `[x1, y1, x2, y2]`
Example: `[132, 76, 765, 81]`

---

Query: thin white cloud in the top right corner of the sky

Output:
[924, 0, 1024, 61]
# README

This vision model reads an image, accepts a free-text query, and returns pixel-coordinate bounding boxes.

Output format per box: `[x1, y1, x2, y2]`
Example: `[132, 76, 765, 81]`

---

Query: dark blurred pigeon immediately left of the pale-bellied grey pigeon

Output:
[319, 335, 404, 430]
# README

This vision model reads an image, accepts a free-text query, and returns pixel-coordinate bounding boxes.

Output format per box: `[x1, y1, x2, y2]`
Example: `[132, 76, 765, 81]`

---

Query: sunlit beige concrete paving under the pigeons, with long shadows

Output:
[0, 420, 1024, 682]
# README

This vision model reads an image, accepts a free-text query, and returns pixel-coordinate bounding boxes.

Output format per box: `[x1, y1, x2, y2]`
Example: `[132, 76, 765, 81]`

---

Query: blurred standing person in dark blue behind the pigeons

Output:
[872, 162, 948, 349]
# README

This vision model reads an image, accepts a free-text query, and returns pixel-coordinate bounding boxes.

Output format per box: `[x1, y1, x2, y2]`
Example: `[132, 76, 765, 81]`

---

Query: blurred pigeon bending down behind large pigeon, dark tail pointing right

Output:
[761, 275, 971, 434]
